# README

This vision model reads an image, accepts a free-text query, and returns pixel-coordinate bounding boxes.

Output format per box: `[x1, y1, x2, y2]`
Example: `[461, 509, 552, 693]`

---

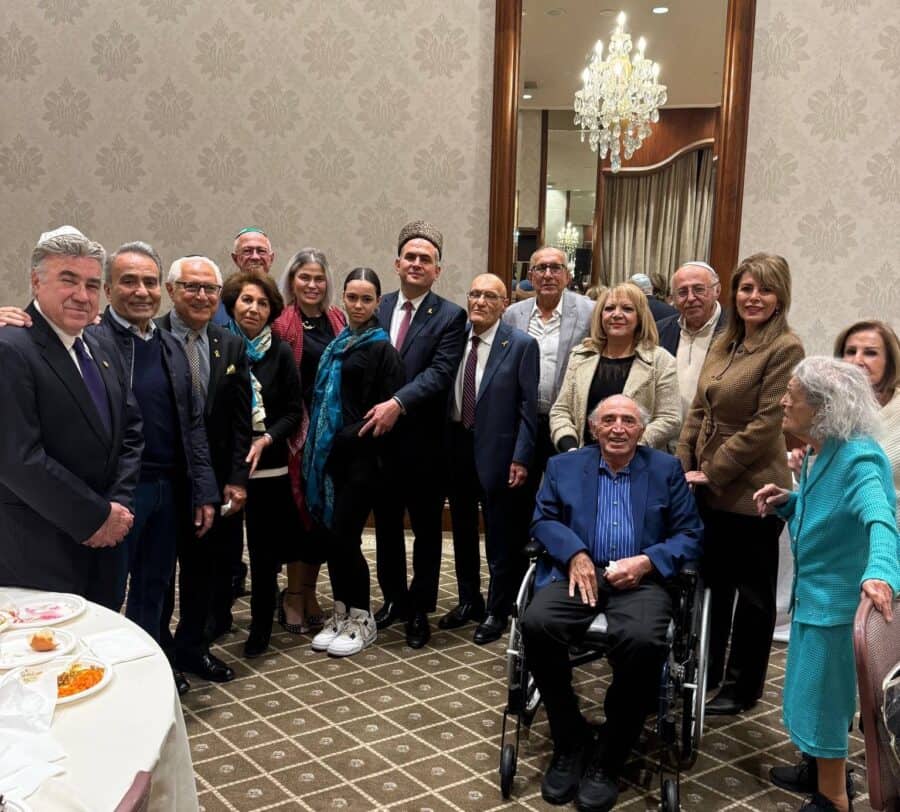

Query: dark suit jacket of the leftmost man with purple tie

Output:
[0, 304, 143, 595]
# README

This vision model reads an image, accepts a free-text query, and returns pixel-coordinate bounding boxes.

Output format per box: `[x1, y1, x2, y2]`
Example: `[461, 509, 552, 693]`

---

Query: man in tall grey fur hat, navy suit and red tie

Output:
[360, 221, 466, 648]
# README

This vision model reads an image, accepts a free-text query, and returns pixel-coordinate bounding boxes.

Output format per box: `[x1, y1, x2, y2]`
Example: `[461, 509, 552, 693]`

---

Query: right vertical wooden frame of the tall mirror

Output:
[709, 0, 756, 298]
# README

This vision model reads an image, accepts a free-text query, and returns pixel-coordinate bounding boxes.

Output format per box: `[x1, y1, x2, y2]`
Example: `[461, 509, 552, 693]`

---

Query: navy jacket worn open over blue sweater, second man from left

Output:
[96, 307, 221, 508]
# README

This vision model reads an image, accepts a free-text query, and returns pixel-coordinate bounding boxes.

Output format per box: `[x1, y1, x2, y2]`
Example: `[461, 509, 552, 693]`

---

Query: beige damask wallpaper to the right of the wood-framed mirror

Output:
[740, 0, 900, 354]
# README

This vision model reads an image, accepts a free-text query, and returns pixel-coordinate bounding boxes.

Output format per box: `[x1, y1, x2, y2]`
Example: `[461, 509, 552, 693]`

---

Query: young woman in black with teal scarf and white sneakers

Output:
[303, 268, 404, 657]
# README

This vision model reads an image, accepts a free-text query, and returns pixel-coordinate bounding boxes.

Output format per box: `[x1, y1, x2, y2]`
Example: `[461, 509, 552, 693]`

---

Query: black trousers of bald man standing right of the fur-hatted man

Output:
[447, 422, 534, 617]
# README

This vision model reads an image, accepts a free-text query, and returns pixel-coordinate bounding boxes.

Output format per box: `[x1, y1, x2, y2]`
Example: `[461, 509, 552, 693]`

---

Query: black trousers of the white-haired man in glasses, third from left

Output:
[160, 513, 244, 661]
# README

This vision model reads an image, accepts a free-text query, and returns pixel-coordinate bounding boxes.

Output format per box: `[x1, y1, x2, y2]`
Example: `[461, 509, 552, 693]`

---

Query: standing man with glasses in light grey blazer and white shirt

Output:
[503, 246, 594, 498]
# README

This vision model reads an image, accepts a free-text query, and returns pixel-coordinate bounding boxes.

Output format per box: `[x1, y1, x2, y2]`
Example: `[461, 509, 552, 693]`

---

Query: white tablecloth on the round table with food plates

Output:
[0, 587, 198, 812]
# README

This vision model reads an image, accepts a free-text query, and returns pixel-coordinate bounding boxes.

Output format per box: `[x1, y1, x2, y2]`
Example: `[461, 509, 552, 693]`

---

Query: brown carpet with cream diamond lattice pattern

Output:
[183, 537, 869, 812]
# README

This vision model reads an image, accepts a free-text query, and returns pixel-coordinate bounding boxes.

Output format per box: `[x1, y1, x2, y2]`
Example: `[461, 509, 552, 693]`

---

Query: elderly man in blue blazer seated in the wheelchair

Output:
[522, 395, 703, 810]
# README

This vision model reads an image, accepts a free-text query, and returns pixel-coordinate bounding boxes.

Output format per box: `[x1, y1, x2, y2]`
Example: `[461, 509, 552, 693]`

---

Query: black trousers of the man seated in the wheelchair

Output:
[522, 571, 672, 776]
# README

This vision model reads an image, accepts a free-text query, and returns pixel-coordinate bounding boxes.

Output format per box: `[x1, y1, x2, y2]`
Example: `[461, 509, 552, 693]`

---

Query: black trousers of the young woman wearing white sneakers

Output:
[327, 454, 380, 611]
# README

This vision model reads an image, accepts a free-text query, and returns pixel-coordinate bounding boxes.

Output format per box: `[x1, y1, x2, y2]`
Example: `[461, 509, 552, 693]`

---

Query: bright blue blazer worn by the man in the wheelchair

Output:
[531, 445, 703, 586]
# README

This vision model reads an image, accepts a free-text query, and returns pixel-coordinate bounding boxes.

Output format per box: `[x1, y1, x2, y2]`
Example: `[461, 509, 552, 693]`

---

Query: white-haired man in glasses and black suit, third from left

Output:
[157, 256, 251, 693]
